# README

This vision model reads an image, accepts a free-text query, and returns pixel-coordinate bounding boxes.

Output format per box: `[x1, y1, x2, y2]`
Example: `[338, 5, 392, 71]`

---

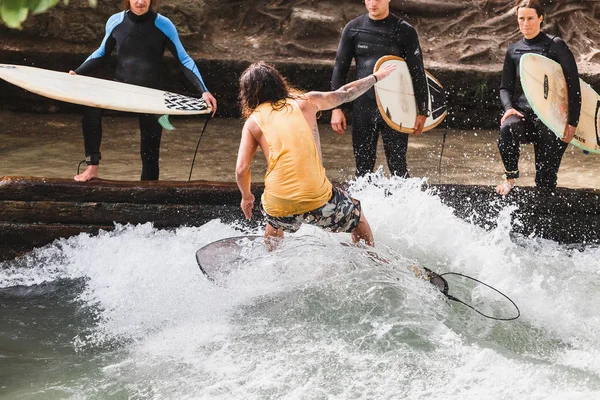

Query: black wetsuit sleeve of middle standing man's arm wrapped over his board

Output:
[400, 23, 429, 115]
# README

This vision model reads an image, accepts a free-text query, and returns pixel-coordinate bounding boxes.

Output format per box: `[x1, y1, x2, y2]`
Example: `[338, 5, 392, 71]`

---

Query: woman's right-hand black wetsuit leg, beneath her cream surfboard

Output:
[533, 118, 569, 189]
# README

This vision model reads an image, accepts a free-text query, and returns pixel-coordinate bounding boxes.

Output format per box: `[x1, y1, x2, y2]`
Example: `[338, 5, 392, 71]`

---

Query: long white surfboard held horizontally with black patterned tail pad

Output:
[0, 64, 212, 115]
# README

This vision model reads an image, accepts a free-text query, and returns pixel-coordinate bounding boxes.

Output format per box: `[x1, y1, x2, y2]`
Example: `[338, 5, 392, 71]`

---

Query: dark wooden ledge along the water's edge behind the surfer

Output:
[0, 176, 600, 261]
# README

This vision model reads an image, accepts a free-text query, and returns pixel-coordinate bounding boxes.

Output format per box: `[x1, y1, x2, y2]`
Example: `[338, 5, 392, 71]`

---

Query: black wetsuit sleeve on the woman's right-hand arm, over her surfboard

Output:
[550, 37, 581, 126]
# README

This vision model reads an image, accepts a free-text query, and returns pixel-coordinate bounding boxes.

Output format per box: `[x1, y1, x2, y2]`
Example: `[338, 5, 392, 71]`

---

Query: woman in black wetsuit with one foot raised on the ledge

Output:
[496, 0, 581, 196]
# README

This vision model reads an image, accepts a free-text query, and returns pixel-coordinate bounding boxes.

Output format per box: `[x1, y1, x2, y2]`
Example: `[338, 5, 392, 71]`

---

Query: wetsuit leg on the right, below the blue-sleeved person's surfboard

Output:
[139, 114, 162, 181]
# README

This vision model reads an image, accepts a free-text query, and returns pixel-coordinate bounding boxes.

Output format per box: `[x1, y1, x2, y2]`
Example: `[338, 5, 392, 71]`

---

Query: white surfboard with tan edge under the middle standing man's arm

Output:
[373, 56, 447, 133]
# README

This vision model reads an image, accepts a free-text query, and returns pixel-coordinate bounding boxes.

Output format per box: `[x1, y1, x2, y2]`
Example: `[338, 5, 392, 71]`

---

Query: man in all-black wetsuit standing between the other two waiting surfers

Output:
[331, 0, 430, 177]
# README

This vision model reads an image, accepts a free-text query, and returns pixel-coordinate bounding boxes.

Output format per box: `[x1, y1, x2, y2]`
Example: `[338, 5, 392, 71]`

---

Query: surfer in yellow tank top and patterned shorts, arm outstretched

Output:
[236, 62, 395, 246]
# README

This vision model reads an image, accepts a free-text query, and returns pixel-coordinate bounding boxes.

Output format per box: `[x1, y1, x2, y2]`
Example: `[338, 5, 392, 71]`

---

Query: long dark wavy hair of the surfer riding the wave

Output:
[239, 61, 298, 118]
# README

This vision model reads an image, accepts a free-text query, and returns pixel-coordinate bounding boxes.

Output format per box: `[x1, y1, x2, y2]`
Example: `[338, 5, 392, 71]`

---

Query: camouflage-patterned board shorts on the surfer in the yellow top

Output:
[262, 187, 361, 232]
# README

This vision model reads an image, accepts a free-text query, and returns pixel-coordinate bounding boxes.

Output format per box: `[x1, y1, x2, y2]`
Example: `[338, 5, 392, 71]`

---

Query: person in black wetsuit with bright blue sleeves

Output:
[69, 0, 217, 182]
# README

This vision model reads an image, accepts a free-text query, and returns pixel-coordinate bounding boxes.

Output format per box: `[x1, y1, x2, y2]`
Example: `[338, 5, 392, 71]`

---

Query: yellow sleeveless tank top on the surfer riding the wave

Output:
[250, 99, 331, 217]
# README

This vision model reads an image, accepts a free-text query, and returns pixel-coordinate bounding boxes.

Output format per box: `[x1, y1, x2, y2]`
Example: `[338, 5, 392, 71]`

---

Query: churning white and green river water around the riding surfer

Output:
[0, 175, 600, 400]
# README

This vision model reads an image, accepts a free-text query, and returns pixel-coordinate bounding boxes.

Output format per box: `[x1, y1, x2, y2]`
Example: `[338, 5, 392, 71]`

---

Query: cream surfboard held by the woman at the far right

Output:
[519, 53, 600, 153]
